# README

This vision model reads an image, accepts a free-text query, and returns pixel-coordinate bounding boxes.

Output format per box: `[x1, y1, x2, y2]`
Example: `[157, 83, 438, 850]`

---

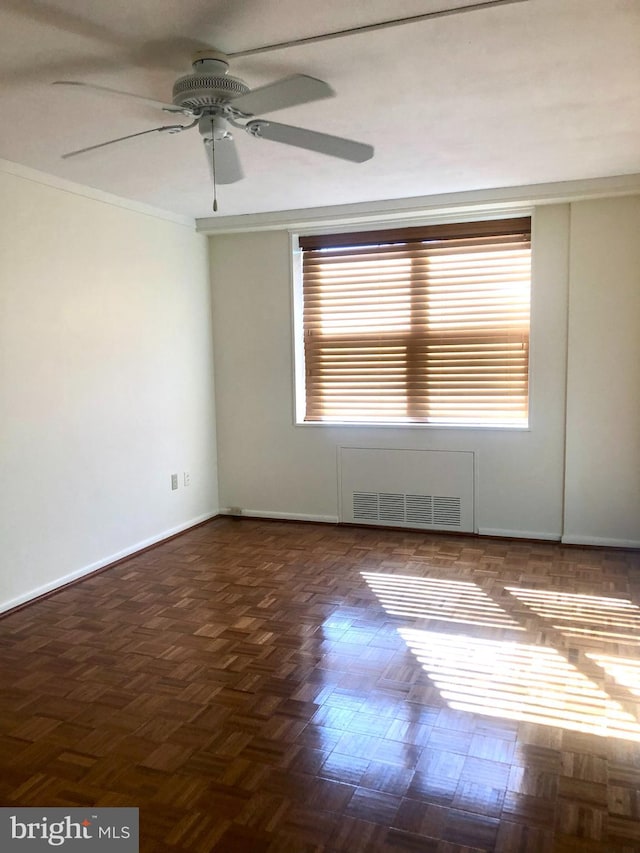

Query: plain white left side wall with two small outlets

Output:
[0, 166, 218, 609]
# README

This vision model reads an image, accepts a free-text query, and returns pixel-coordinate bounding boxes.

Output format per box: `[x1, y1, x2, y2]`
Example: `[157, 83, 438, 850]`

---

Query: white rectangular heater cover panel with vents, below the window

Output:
[338, 447, 475, 533]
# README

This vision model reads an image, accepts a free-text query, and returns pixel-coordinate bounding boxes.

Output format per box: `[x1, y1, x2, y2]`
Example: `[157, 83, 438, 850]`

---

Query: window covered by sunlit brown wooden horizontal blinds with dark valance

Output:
[299, 217, 531, 426]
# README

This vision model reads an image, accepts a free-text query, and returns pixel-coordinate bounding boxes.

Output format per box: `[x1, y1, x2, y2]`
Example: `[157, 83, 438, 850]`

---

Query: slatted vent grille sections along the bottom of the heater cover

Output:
[353, 492, 462, 528]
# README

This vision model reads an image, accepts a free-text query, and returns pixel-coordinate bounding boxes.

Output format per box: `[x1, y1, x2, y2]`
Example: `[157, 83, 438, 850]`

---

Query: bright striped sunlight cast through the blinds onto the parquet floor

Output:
[362, 572, 640, 741]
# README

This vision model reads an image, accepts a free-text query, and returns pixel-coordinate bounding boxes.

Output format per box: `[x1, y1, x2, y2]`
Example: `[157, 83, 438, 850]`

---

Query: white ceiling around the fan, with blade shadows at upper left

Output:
[0, 0, 640, 217]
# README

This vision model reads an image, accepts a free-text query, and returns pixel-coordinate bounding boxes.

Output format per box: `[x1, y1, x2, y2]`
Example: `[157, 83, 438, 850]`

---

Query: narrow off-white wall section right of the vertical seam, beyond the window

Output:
[565, 196, 640, 546]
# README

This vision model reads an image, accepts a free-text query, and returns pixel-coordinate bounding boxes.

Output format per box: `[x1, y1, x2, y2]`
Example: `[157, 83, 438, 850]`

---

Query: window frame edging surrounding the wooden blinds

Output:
[290, 208, 534, 432]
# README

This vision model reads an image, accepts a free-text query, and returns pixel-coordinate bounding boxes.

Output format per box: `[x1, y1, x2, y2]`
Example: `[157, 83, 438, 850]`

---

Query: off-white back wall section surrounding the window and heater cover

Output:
[210, 205, 569, 538]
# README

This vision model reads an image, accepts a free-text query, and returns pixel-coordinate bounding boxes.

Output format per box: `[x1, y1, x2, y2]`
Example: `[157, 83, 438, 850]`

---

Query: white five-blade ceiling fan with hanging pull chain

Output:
[53, 50, 373, 210]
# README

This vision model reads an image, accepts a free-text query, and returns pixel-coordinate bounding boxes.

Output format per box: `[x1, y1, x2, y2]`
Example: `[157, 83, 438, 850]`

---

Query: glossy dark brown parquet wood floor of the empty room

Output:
[0, 519, 640, 853]
